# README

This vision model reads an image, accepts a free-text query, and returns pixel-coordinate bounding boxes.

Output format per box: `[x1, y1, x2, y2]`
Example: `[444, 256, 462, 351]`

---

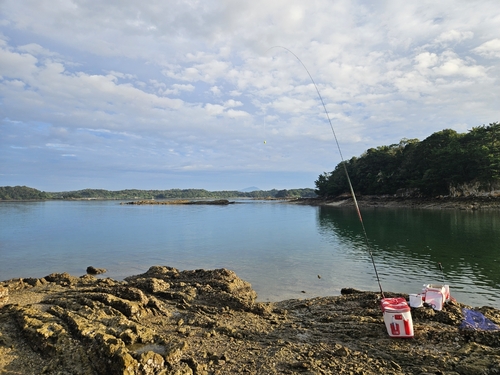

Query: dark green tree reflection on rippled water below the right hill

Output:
[318, 207, 500, 306]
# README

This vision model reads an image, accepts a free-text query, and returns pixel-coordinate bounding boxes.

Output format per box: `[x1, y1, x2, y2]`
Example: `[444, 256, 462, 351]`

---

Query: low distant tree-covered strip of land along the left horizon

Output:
[0, 186, 316, 200]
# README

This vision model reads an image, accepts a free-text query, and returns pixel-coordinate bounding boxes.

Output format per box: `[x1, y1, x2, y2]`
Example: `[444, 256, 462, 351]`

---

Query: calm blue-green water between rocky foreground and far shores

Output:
[0, 201, 500, 308]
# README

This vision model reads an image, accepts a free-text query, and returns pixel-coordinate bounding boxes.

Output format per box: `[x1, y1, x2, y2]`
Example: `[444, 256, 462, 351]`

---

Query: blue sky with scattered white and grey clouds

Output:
[0, 0, 500, 192]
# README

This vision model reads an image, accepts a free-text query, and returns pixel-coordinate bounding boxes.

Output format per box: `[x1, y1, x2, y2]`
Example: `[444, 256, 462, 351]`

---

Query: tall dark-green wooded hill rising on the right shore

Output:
[315, 122, 500, 197]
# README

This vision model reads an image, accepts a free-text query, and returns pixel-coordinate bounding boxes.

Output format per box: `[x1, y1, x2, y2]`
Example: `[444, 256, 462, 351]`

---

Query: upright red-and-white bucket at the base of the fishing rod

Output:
[380, 297, 413, 338]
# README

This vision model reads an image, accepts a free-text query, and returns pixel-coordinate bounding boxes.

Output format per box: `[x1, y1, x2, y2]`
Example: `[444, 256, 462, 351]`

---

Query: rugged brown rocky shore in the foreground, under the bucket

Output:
[0, 266, 500, 375]
